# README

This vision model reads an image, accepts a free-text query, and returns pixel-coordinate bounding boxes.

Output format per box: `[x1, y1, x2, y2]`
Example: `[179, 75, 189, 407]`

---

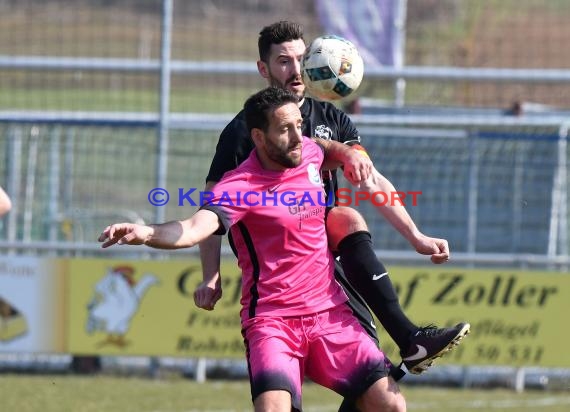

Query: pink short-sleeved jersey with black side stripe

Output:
[203, 138, 347, 320]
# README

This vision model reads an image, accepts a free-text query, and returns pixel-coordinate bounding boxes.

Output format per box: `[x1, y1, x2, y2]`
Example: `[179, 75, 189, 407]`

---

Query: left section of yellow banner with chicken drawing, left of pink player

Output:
[68, 258, 244, 357]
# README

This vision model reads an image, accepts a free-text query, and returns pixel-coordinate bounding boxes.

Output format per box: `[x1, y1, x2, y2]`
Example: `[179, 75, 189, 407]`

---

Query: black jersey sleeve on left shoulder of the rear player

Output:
[202, 112, 253, 182]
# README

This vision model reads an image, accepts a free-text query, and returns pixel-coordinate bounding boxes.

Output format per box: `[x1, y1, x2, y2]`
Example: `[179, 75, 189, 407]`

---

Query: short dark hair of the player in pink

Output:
[243, 86, 299, 132]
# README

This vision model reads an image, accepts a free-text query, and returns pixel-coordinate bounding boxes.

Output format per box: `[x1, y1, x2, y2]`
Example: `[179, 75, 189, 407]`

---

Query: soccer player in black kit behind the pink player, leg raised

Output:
[194, 21, 470, 402]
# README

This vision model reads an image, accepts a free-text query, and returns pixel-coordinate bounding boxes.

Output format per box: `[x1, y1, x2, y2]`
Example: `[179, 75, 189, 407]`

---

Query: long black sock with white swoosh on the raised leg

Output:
[338, 231, 418, 350]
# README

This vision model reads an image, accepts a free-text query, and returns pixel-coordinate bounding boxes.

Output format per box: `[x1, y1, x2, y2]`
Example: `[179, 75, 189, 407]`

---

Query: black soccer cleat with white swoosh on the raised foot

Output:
[400, 323, 471, 375]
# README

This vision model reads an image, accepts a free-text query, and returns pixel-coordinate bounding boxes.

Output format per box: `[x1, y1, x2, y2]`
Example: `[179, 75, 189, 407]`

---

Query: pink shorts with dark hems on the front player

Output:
[242, 305, 391, 410]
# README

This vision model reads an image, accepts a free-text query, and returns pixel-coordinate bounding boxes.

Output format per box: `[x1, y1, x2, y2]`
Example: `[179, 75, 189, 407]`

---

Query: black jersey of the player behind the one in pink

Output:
[206, 97, 360, 204]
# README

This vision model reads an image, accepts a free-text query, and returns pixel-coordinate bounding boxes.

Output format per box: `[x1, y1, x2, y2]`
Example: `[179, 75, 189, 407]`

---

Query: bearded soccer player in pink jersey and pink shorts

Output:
[99, 87, 406, 412]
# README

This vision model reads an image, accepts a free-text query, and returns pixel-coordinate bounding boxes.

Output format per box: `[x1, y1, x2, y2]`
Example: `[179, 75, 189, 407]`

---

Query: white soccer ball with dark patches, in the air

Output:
[301, 36, 364, 101]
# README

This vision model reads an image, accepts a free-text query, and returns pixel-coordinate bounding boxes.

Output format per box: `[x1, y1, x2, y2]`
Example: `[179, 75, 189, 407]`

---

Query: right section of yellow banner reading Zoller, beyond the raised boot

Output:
[366, 266, 570, 367]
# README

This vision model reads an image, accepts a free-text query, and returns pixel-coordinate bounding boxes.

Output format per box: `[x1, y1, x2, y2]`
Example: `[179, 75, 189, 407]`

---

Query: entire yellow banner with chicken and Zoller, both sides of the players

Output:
[64, 259, 570, 367]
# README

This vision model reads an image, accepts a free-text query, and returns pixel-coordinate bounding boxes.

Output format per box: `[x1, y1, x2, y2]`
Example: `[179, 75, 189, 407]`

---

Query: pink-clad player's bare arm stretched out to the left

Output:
[99, 210, 219, 249]
